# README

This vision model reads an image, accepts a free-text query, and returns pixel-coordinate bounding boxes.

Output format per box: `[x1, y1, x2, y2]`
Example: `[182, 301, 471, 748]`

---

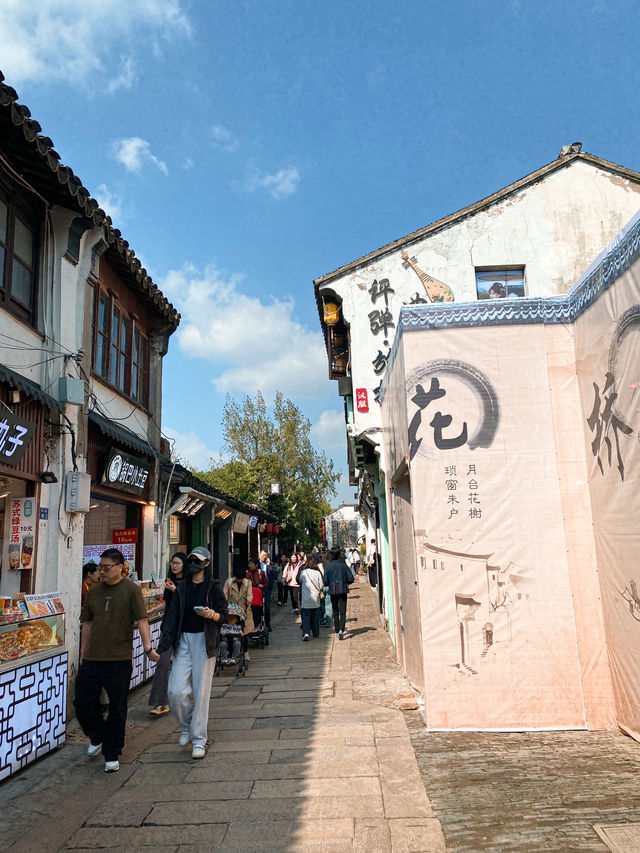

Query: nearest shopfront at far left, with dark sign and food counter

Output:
[0, 366, 68, 779]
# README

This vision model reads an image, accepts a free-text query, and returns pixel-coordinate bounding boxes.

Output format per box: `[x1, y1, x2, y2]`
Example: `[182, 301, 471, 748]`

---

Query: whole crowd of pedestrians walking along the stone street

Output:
[75, 547, 368, 772]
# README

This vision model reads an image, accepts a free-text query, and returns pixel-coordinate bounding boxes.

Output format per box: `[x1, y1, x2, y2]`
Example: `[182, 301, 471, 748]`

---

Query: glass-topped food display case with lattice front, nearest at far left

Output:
[0, 605, 67, 779]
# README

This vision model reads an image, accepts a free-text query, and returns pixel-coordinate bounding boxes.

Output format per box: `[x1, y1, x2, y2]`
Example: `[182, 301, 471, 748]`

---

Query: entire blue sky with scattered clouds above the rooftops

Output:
[0, 0, 640, 499]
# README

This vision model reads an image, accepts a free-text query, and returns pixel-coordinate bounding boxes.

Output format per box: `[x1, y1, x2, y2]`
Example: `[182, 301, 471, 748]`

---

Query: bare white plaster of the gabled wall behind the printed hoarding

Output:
[326, 160, 640, 452]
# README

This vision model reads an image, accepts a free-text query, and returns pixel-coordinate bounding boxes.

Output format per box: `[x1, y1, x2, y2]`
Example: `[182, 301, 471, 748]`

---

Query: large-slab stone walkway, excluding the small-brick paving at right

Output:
[0, 579, 445, 853]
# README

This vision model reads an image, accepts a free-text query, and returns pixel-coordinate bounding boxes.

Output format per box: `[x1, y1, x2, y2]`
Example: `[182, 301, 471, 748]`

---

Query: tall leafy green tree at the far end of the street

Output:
[198, 391, 340, 548]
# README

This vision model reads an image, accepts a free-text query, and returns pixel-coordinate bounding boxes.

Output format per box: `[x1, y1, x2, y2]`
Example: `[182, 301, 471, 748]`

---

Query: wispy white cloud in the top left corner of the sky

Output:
[0, 0, 191, 85]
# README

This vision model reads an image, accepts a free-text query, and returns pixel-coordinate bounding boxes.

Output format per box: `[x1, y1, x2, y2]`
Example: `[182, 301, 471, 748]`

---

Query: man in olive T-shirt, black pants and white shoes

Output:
[74, 548, 159, 773]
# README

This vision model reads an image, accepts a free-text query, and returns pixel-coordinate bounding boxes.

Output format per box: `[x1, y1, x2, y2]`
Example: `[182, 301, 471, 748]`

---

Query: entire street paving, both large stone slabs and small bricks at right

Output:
[0, 583, 640, 853]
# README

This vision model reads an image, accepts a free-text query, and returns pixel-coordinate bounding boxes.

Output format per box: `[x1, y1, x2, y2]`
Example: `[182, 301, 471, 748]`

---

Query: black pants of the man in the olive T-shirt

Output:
[74, 660, 132, 761]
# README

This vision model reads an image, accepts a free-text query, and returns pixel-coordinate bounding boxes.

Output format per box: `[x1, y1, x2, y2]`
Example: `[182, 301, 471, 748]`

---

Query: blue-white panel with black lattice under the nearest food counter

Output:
[0, 652, 68, 779]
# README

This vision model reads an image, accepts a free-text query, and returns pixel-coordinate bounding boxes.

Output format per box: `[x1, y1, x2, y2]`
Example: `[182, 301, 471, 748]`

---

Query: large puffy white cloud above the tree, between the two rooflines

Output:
[160, 266, 330, 400]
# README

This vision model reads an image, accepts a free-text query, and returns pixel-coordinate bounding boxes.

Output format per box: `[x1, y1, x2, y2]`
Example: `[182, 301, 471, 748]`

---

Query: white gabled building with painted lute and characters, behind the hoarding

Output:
[314, 143, 640, 637]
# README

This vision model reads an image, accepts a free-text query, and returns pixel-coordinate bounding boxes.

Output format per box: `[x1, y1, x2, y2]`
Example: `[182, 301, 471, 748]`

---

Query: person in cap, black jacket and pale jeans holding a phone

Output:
[158, 547, 227, 758]
